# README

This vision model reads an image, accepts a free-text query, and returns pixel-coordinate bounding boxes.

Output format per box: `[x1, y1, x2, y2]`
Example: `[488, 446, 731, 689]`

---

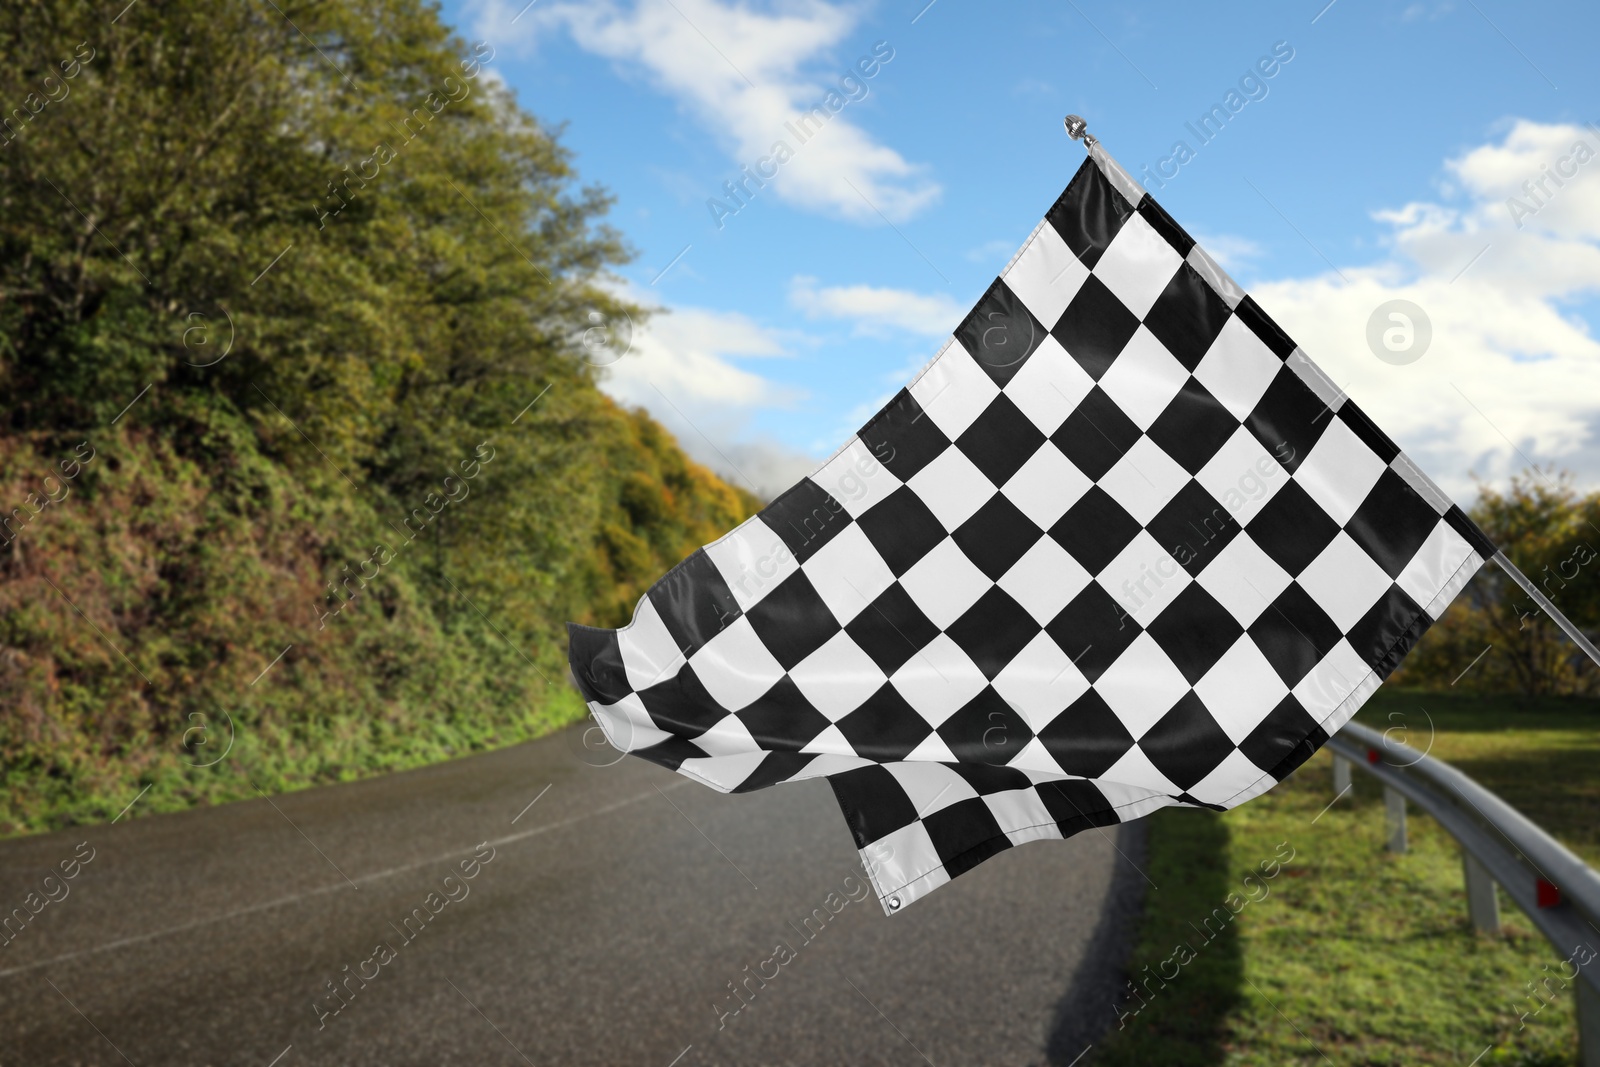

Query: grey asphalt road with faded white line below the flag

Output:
[0, 729, 1142, 1067]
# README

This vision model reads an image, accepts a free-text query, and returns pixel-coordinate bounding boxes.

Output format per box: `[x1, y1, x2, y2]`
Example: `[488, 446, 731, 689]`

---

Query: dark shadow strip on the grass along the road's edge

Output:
[1075, 808, 1245, 1067]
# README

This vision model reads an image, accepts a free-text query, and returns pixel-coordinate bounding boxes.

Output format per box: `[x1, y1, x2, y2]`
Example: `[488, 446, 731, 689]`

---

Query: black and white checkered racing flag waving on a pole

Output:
[571, 147, 1494, 912]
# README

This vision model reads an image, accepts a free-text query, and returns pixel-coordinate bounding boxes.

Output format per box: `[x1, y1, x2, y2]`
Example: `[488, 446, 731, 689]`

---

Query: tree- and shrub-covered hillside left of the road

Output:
[0, 0, 757, 833]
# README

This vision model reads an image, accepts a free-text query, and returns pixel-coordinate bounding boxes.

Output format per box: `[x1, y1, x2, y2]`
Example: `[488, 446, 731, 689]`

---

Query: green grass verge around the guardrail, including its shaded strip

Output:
[1085, 689, 1600, 1067]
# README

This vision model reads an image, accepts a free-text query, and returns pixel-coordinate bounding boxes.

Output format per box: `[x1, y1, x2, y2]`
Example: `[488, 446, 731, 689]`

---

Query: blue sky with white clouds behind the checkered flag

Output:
[442, 0, 1600, 504]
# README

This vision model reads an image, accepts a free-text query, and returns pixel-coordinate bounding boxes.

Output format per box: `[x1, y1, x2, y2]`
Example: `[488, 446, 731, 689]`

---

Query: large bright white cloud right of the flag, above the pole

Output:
[1253, 120, 1600, 502]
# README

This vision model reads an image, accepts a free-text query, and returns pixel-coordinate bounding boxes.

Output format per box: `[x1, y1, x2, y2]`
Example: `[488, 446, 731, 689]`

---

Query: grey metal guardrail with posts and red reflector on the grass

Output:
[1328, 723, 1600, 1067]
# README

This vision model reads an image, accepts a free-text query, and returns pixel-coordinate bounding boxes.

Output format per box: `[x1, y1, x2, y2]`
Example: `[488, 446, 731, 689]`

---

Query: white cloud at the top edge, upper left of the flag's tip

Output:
[474, 0, 939, 222]
